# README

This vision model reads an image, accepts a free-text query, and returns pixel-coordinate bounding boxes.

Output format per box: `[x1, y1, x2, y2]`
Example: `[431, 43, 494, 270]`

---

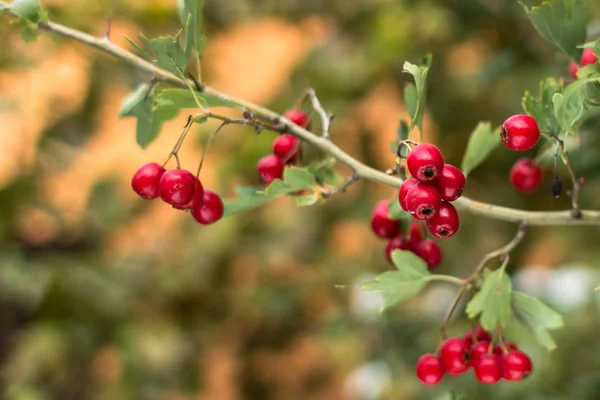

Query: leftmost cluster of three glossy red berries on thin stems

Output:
[131, 162, 223, 225]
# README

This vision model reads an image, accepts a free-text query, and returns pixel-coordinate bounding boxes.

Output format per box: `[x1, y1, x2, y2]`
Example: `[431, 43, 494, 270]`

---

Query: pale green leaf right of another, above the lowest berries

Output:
[512, 292, 563, 351]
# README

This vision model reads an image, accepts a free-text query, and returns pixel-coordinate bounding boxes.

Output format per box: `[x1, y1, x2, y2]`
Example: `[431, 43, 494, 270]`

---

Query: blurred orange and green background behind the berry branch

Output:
[0, 0, 600, 400]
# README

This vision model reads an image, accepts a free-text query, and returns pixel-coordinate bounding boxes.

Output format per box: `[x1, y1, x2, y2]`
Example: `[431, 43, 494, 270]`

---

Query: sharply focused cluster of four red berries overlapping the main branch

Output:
[398, 143, 466, 239]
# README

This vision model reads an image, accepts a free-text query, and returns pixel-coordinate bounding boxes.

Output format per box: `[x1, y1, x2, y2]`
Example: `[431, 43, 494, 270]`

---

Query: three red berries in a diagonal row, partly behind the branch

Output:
[256, 110, 310, 185]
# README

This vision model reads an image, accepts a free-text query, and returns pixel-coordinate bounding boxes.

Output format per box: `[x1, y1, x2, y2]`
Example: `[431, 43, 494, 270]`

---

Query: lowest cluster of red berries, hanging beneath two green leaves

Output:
[416, 328, 533, 385]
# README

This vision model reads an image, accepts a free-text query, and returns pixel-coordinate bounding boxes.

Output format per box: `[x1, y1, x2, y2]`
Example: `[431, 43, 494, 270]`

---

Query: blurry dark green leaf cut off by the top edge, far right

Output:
[521, 0, 587, 64]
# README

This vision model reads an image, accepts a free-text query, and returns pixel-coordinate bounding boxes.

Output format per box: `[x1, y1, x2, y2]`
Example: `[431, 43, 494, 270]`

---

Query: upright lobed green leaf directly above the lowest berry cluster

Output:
[466, 268, 512, 331]
